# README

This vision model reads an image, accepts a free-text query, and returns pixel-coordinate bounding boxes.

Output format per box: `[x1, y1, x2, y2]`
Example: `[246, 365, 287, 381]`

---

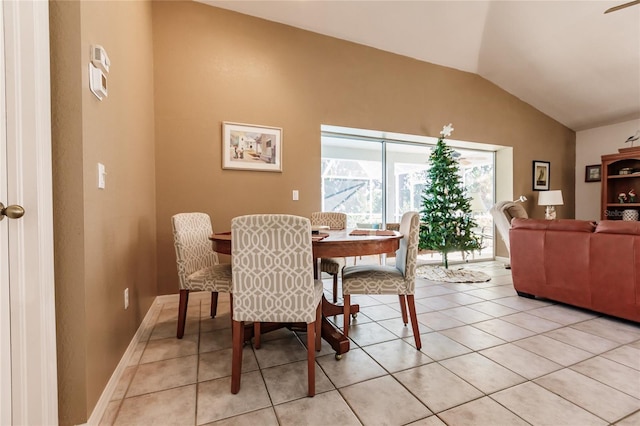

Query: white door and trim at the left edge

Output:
[0, 0, 58, 425]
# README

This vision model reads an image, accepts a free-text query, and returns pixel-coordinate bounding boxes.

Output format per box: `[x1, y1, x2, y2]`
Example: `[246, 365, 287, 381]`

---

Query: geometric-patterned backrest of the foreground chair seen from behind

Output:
[231, 214, 316, 323]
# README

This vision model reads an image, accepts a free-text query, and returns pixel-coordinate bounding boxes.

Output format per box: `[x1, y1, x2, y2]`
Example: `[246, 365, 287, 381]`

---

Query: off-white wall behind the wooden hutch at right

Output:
[575, 119, 640, 220]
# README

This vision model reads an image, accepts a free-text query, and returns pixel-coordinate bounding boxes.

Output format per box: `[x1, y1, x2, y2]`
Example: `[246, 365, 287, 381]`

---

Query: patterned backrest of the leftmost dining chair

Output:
[171, 213, 218, 289]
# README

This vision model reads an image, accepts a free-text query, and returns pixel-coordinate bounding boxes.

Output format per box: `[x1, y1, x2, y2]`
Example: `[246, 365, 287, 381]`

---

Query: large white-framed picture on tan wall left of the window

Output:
[222, 121, 282, 172]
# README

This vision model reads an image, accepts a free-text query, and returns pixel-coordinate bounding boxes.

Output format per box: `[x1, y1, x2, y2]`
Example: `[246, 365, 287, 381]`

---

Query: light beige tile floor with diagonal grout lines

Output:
[101, 262, 640, 426]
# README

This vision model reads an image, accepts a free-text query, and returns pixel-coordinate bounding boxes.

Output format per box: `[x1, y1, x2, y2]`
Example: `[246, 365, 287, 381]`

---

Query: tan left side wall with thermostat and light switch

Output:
[50, 1, 157, 424]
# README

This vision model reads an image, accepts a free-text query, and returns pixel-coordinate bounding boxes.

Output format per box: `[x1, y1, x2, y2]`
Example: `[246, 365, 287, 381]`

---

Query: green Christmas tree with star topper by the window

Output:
[419, 123, 481, 268]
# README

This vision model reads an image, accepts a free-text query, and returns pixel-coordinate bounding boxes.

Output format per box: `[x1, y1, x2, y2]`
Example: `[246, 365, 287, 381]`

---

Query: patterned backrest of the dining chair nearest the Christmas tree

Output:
[396, 212, 420, 294]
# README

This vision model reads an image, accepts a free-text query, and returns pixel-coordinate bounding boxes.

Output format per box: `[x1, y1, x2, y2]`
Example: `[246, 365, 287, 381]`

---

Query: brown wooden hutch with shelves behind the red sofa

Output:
[600, 147, 640, 220]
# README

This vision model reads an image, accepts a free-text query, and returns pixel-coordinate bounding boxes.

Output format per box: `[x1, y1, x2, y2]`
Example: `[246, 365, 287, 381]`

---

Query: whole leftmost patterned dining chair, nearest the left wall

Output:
[171, 213, 232, 339]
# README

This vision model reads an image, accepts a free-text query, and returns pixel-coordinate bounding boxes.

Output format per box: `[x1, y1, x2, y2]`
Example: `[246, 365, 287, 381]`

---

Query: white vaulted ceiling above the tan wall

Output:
[197, 0, 640, 131]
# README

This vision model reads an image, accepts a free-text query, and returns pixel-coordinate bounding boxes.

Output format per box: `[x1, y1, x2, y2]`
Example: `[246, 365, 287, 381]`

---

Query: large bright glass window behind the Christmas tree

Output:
[322, 126, 495, 260]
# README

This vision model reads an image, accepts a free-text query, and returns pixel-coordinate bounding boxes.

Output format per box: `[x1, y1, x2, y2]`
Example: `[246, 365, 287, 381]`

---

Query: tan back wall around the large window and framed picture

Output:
[153, 2, 575, 282]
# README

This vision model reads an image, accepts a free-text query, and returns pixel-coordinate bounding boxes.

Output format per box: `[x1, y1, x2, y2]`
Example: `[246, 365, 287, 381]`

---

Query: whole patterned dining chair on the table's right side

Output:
[342, 212, 422, 349]
